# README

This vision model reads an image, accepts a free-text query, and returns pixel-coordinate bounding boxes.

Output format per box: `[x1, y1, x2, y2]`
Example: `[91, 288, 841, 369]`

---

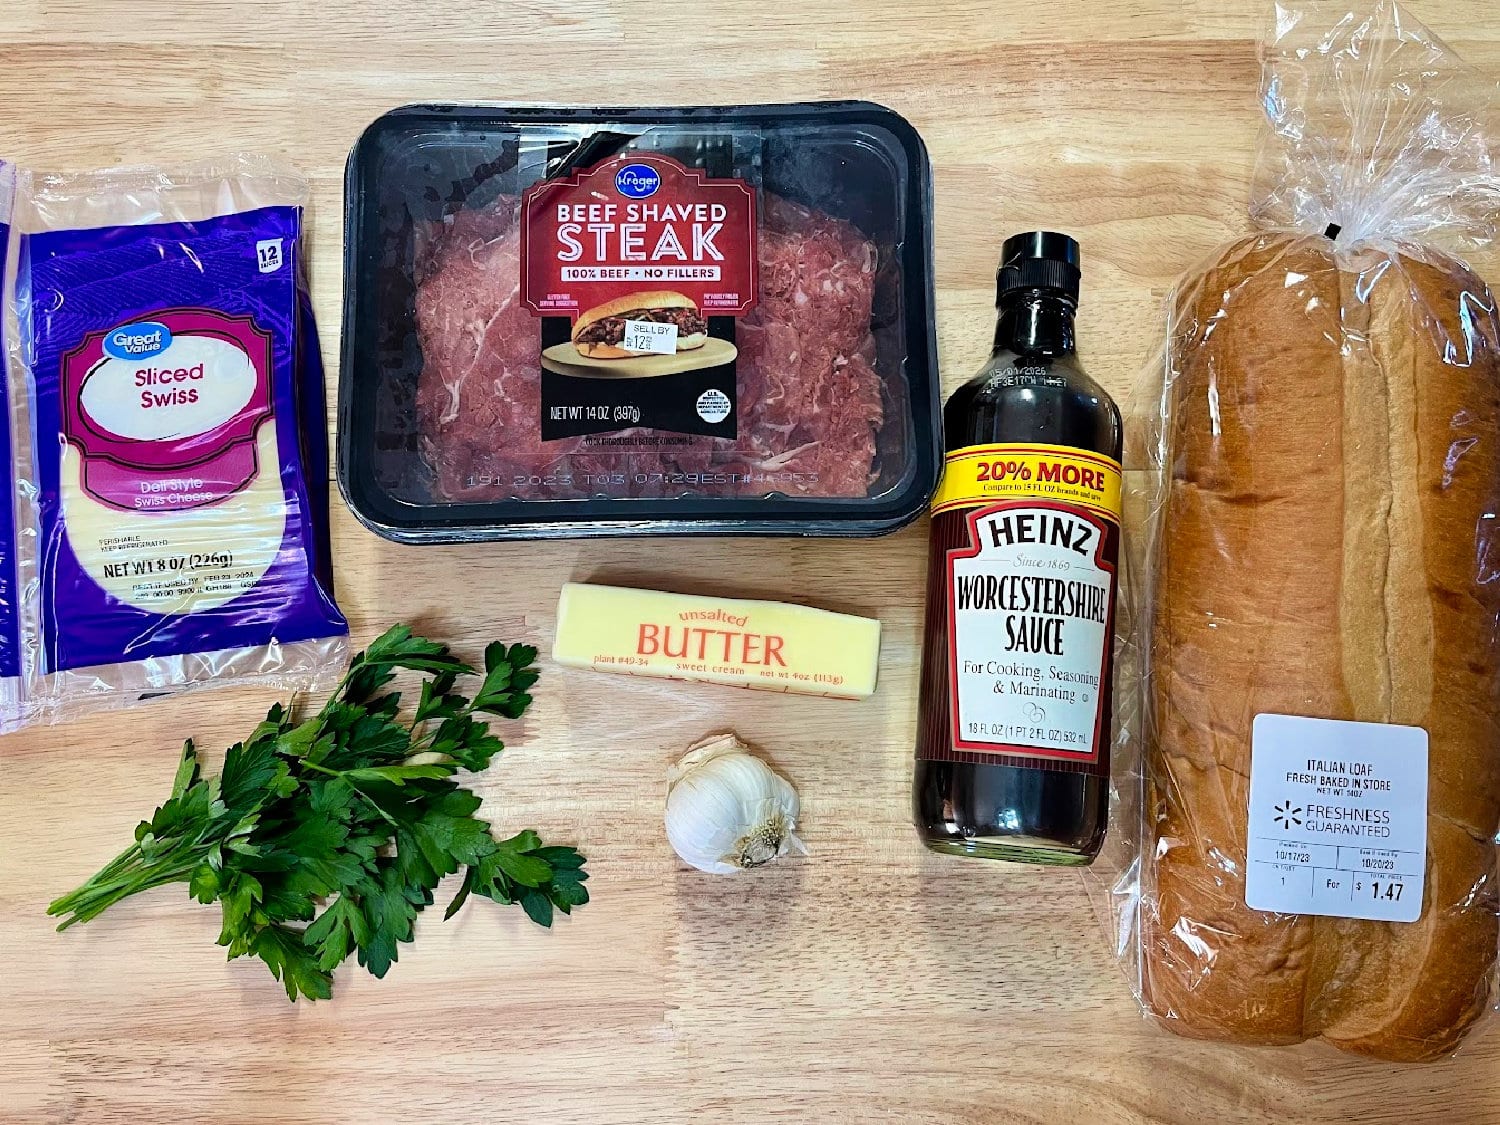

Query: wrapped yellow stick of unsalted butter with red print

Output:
[552, 582, 881, 699]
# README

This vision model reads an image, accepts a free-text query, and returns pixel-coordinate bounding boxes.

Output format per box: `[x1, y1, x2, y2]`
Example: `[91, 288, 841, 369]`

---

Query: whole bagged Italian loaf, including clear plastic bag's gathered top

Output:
[1101, 3, 1500, 1061]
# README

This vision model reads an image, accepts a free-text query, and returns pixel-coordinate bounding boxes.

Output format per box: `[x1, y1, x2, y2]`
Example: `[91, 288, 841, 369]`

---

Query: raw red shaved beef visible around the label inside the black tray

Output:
[417, 195, 884, 501]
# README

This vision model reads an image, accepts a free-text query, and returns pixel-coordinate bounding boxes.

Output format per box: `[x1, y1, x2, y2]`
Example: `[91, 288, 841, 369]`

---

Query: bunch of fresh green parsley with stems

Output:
[47, 626, 588, 1001]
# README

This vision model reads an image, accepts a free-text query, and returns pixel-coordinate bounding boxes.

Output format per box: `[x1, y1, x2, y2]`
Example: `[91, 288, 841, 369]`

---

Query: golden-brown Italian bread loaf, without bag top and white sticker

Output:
[1142, 234, 1500, 1061]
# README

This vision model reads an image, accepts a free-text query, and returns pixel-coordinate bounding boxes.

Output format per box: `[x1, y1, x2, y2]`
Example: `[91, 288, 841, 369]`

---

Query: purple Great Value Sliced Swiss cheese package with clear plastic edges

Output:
[9, 158, 348, 719]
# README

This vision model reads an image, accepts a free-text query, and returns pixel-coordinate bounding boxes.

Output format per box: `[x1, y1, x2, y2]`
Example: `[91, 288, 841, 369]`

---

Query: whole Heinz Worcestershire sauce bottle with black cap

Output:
[912, 231, 1121, 864]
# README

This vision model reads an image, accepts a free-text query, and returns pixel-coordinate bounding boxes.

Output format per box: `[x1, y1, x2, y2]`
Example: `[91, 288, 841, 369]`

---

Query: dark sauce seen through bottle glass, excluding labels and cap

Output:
[912, 294, 1122, 864]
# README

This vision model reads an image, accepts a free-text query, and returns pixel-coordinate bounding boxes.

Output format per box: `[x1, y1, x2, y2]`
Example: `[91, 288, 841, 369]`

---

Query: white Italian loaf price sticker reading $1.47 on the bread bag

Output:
[1245, 714, 1428, 923]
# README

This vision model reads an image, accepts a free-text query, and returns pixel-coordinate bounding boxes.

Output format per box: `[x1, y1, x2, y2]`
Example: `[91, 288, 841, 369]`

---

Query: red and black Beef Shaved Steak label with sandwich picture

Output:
[521, 153, 759, 447]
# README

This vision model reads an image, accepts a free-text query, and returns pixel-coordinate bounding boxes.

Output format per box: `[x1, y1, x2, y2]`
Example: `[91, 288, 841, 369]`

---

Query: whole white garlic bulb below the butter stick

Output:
[666, 735, 807, 875]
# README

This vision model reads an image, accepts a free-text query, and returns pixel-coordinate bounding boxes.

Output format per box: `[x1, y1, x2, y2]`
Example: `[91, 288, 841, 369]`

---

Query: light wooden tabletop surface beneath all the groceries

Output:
[0, 0, 1500, 1125]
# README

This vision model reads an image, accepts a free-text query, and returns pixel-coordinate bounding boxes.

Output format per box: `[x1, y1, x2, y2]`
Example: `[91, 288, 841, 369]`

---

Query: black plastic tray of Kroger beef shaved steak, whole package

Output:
[339, 102, 938, 542]
